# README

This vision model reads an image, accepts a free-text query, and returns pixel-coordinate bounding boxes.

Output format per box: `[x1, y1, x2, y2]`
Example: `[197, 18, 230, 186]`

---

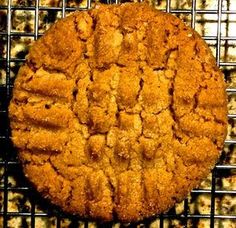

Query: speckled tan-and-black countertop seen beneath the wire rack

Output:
[0, 0, 236, 228]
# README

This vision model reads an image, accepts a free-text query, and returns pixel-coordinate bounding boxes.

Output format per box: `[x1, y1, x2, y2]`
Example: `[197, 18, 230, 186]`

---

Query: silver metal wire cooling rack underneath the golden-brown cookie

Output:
[0, 0, 236, 227]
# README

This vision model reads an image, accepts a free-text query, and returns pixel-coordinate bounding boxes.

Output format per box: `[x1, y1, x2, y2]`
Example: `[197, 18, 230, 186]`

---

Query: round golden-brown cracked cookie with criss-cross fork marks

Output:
[9, 3, 227, 221]
